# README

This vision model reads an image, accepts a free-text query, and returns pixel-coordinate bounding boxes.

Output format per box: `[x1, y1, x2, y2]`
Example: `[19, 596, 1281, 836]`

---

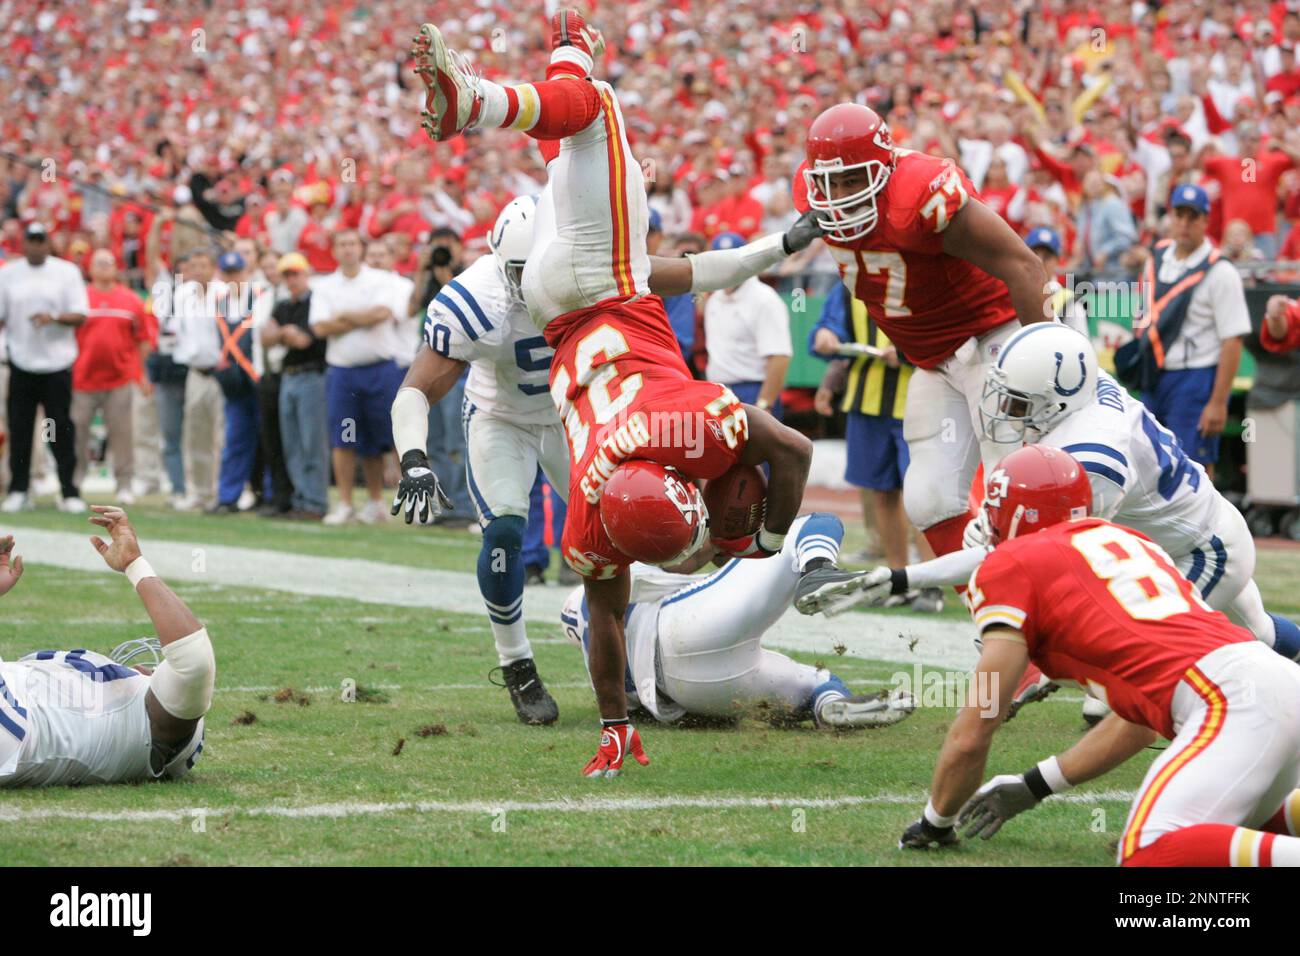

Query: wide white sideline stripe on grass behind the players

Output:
[21, 528, 976, 669]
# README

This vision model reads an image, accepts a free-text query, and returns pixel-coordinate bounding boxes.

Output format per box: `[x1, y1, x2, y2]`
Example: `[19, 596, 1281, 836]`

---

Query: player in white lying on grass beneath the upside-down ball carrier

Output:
[560, 512, 915, 727]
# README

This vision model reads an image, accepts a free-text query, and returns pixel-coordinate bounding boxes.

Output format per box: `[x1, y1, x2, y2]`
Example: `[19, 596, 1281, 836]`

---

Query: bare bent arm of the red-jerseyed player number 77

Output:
[944, 202, 1054, 325]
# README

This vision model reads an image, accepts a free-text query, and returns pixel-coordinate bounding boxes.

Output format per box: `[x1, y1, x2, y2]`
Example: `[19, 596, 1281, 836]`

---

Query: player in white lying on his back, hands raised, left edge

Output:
[0, 506, 217, 787]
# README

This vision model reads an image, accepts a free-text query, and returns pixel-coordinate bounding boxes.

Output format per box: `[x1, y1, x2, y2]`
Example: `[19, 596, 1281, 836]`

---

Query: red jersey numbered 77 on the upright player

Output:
[794, 150, 1015, 368]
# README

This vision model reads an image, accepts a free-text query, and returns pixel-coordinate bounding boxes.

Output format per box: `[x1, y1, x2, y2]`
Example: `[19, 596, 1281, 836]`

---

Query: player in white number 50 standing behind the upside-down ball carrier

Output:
[393, 186, 815, 724]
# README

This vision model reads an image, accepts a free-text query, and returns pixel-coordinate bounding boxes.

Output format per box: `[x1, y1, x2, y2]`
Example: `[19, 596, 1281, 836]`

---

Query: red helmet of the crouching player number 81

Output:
[984, 445, 1092, 544]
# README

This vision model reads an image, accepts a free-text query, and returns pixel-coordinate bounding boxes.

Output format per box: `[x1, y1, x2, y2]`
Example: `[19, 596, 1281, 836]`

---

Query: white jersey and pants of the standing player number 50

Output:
[424, 254, 568, 527]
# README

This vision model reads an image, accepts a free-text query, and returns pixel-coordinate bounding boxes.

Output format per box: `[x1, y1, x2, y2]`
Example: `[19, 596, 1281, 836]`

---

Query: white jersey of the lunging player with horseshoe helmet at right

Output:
[1039, 372, 1221, 557]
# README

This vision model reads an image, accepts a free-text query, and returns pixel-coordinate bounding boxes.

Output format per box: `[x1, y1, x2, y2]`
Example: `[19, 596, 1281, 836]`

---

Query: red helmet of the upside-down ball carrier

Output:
[601, 460, 709, 564]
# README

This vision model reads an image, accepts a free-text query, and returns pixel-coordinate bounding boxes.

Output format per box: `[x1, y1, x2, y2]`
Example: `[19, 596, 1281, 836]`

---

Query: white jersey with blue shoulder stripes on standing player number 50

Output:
[424, 252, 558, 425]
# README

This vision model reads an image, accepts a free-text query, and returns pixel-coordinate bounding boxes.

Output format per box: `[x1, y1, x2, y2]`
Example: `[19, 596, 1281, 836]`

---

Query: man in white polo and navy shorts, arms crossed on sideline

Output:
[308, 230, 402, 524]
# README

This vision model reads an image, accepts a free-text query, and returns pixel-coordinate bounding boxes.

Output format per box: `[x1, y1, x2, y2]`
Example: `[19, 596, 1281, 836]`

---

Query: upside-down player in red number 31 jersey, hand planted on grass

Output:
[412, 10, 816, 777]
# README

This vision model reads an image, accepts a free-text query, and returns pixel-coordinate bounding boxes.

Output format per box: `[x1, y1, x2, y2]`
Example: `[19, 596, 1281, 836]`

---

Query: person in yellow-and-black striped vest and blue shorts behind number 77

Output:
[810, 286, 944, 613]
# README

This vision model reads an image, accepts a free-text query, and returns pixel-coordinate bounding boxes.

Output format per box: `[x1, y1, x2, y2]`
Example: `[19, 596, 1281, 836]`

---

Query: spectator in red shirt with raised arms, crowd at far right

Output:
[1203, 122, 1300, 259]
